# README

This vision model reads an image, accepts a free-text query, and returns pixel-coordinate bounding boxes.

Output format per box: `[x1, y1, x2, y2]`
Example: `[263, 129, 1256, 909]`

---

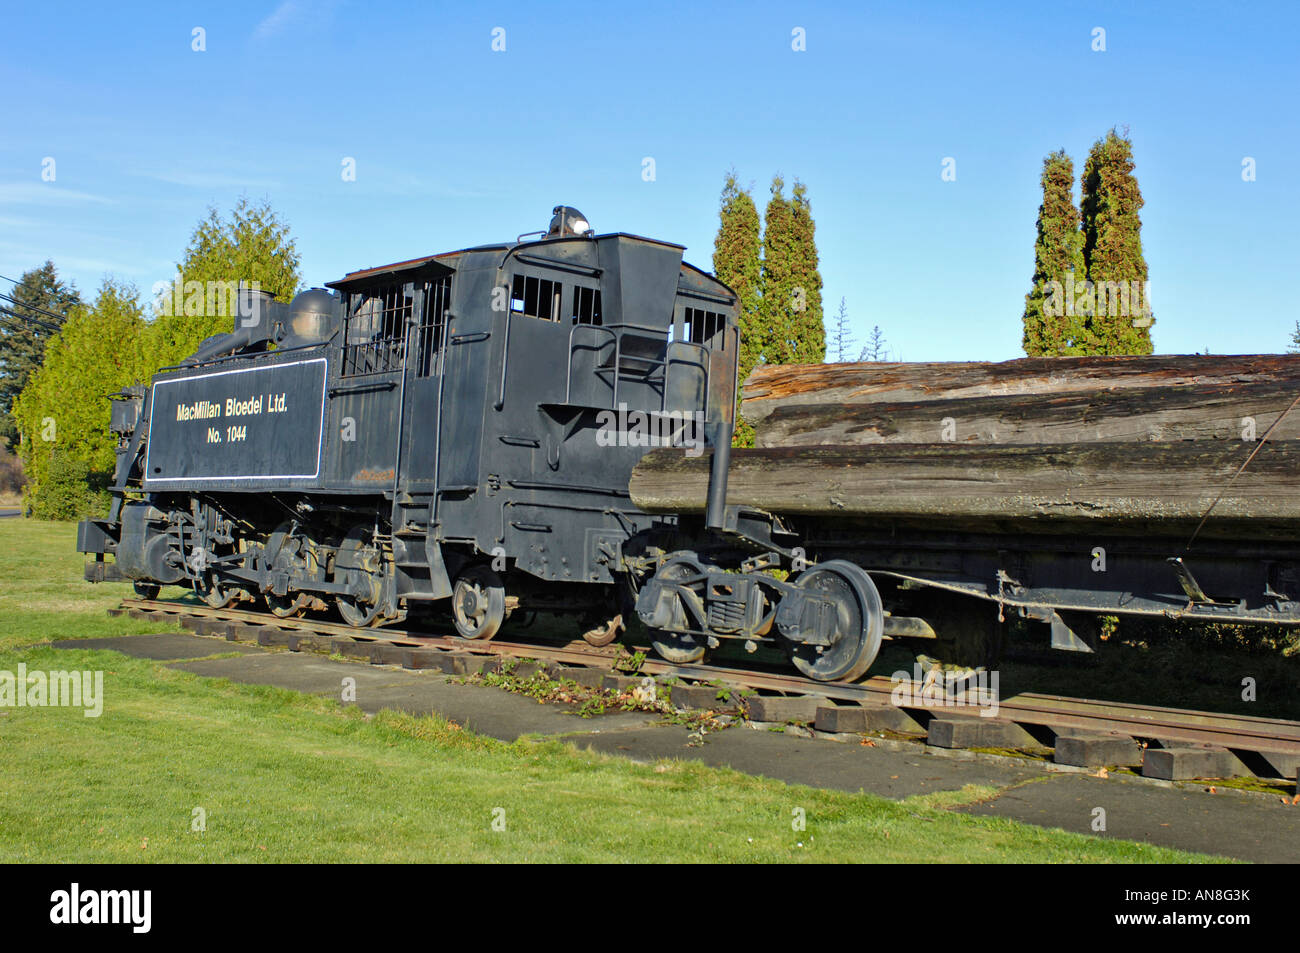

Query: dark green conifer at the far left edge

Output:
[0, 261, 81, 445]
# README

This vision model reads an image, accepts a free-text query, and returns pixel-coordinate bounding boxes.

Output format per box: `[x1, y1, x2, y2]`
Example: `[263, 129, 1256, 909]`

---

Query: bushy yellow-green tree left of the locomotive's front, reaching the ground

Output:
[14, 278, 148, 519]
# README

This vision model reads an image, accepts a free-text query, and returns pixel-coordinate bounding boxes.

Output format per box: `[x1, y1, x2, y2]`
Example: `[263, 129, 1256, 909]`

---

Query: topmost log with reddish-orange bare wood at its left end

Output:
[741, 354, 1300, 429]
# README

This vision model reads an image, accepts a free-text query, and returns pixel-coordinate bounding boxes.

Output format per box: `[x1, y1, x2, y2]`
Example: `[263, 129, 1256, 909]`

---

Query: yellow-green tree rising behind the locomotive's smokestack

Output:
[151, 199, 302, 369]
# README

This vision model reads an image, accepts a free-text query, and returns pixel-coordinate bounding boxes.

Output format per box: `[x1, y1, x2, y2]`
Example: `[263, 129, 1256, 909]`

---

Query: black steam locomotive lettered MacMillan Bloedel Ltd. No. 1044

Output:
[78, 205, 894, 680]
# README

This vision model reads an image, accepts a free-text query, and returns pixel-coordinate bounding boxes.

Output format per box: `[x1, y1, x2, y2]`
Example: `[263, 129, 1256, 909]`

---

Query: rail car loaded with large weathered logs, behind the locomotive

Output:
[632, 355, 1300, 677]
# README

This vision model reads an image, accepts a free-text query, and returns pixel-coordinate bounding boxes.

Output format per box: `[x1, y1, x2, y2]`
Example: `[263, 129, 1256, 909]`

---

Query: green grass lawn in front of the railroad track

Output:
[0, 519, 1227, 863]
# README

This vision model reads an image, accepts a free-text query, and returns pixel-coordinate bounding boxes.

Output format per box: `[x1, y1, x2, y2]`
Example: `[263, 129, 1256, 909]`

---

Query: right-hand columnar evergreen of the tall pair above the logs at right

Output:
[1076, 129, 1154, 354]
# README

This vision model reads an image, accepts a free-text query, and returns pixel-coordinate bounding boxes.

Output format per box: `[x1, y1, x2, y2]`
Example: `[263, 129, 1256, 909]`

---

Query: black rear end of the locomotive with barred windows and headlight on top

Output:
[392, 209, 738, 633]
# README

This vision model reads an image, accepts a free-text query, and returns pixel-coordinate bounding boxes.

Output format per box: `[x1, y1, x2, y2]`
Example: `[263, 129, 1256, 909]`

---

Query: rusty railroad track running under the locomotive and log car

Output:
[116, 599, 1300, 780]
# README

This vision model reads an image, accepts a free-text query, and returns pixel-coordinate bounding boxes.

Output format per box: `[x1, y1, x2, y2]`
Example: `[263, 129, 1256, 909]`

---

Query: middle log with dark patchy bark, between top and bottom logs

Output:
[755, 382, 1300, 447]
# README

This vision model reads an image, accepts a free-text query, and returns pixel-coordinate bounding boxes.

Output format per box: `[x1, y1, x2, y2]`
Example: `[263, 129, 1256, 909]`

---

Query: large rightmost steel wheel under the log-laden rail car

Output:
[790, 559, 885, 681]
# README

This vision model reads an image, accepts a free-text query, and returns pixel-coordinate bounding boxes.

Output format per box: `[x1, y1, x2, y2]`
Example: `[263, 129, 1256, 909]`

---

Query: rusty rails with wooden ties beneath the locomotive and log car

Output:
[112, 599, 1300, 781]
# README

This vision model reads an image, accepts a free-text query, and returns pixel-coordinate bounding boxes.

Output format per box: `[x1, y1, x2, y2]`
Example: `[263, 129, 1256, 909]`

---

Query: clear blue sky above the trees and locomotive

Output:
[0, 0, 1300, 360]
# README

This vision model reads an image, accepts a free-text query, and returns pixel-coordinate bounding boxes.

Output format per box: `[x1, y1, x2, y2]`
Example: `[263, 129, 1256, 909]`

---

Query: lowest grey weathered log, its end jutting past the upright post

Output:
[629, 441, 1300, 538]
